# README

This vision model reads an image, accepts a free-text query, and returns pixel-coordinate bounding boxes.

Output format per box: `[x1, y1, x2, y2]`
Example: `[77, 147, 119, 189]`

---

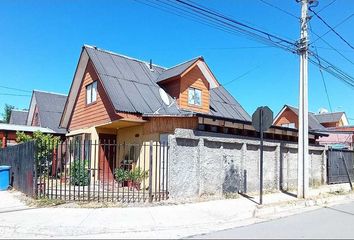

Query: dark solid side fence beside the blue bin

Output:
[0, 141, 36, 197]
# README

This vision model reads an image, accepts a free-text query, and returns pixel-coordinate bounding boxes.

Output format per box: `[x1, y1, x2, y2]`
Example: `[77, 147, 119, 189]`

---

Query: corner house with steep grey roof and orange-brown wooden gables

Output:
[58, 45, 326, 181]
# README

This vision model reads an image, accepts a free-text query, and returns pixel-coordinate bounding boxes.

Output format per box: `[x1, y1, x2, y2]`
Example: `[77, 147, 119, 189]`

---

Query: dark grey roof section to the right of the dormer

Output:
[210, 86, 251, 121]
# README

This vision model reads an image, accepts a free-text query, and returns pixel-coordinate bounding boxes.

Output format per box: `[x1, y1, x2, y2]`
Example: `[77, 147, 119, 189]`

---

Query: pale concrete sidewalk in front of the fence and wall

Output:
[0, 185, 354, 238]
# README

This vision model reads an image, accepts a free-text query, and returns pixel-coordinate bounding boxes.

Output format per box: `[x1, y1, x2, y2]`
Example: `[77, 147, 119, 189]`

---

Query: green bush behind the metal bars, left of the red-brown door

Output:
[70, 160, 90, 186]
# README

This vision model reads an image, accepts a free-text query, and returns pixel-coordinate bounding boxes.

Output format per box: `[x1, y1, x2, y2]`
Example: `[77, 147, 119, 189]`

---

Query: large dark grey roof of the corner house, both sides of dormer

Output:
[85, 46, 250, 120]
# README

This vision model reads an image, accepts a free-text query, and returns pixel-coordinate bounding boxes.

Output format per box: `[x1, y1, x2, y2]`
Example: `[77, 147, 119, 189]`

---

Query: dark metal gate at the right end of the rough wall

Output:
[327, 149, 354, 184]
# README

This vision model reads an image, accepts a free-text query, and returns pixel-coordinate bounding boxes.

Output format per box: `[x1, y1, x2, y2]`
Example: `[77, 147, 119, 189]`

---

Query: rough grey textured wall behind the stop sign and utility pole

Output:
[169, 129, 326, 198]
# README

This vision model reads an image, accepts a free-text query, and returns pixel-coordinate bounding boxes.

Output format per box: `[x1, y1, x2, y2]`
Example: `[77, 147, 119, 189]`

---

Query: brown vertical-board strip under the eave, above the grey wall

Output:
[143, 117, 198, 135]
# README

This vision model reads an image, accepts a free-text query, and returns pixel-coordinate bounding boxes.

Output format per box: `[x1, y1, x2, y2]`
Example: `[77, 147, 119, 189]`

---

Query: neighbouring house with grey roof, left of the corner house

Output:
[26, 90, 67, 138]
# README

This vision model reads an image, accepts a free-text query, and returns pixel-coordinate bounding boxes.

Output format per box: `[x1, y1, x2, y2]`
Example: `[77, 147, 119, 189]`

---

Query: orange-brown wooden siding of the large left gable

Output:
[69, 61, 118, 130]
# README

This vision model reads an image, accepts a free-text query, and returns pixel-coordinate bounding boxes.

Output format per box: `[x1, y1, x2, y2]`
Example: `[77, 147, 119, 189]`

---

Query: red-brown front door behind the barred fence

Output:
[99, 134, 117, 181]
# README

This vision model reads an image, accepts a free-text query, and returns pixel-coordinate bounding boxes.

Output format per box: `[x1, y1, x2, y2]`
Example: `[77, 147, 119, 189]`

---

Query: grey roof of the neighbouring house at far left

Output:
[33, 90, 67, 134]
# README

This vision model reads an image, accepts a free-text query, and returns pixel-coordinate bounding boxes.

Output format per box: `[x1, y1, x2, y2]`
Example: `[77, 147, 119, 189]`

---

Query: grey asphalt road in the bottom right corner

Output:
[193, 202, 354, 239]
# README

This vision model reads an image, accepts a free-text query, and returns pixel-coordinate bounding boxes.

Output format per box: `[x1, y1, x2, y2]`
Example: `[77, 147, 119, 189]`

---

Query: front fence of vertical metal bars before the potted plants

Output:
[35, 140, 168, 203]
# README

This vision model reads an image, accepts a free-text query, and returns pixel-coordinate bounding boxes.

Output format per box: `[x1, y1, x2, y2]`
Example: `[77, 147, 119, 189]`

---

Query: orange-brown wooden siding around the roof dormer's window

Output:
[179, 66, 210, 113]
